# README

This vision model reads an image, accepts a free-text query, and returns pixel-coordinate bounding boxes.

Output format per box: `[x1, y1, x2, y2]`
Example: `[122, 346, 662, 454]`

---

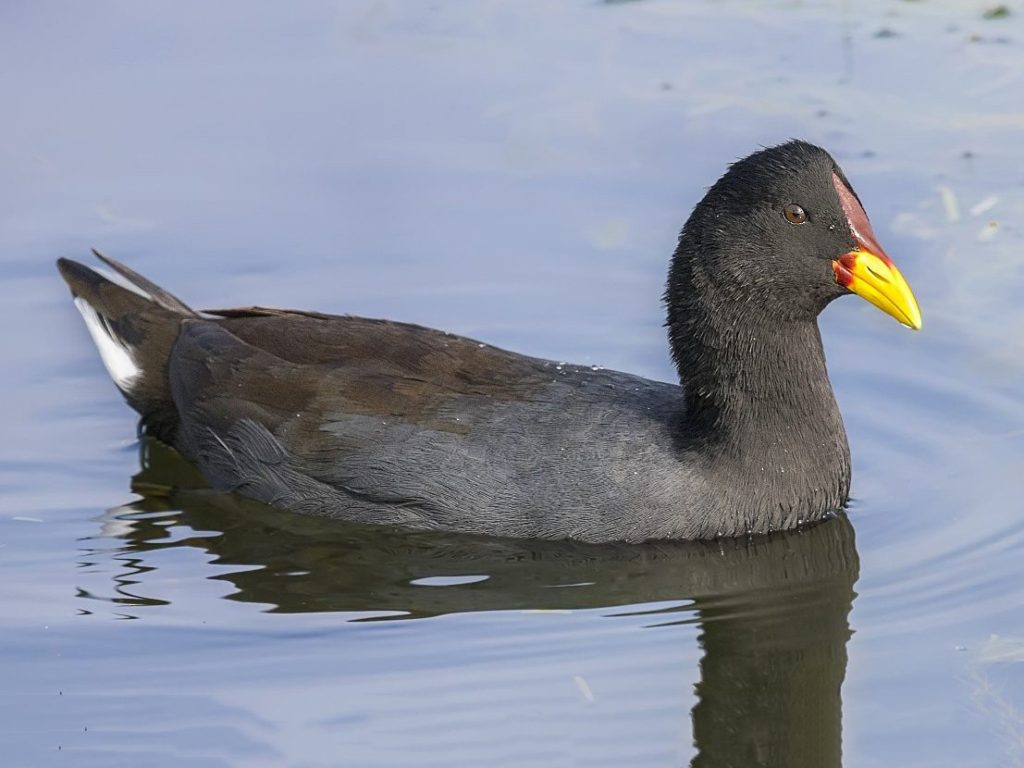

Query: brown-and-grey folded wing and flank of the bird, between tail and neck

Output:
[170, 309, 679, 539]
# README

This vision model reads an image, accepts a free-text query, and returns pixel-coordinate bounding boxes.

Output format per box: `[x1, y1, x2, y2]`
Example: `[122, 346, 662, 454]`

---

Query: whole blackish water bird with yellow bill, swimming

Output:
[58, 141, 921, 542]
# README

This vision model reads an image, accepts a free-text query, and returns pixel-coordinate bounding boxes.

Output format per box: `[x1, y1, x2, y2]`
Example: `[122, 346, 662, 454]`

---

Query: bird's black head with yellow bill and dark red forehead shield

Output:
[666, 141, 922, 330]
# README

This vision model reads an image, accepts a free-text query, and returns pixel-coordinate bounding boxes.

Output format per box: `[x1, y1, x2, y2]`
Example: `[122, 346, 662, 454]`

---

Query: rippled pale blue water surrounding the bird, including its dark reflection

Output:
[0, 0, 1024, 768]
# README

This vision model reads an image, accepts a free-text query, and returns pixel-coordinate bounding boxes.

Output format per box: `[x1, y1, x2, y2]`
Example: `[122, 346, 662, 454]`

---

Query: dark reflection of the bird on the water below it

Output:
[83, 441, 858, 768]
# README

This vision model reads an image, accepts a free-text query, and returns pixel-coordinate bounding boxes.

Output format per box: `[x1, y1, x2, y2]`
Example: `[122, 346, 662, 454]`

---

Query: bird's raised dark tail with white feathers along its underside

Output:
[57, 251, 199, 439]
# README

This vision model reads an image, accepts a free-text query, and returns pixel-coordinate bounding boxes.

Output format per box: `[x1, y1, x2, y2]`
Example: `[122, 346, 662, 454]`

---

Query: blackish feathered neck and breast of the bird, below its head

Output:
[670, 305, 850, 534]
